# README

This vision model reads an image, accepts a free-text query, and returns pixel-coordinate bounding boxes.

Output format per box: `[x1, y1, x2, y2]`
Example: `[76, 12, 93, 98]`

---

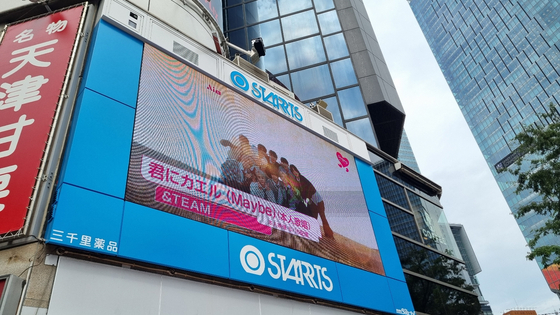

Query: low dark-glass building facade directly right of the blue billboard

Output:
[370, 149, 481, 314]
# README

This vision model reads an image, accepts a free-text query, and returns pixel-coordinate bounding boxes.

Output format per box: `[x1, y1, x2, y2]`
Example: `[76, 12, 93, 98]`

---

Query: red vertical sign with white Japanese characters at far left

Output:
[0, 6, 84, 234]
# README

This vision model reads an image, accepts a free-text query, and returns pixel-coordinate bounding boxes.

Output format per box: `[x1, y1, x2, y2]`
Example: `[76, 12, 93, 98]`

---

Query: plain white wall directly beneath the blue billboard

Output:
[48, 257, 354, 315]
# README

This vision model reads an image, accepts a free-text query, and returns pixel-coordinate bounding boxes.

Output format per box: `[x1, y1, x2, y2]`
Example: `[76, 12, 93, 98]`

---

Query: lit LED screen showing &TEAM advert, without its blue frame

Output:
[125, 45, 384, 275]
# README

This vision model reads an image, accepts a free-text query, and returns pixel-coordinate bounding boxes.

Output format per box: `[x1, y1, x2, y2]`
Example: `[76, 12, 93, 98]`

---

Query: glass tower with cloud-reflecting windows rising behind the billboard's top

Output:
[224, 0, 404, 157]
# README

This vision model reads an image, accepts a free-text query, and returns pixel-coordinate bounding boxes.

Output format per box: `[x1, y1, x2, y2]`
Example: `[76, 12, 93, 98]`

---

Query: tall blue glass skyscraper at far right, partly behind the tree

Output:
[409, 0, 560, 293]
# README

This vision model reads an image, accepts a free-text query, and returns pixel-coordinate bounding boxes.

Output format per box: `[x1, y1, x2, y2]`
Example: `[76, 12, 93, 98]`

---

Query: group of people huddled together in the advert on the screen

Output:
[220, 135, 333, 237]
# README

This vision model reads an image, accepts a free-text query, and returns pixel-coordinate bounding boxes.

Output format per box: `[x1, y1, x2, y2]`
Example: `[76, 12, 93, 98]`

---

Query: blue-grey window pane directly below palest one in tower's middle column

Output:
[292, 65, 334, 102]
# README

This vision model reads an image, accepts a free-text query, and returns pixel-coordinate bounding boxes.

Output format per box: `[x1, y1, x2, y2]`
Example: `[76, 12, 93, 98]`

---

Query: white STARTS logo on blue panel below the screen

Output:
[239, 245, 333, 292]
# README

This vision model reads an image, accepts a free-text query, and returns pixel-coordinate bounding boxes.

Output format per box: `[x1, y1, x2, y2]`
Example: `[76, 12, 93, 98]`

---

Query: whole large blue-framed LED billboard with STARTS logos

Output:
[45, 19, 412, 313]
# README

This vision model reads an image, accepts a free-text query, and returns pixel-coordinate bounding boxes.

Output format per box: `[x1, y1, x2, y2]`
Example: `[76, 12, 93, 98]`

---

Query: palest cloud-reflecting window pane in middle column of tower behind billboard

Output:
[286, 36, 327, 69]
